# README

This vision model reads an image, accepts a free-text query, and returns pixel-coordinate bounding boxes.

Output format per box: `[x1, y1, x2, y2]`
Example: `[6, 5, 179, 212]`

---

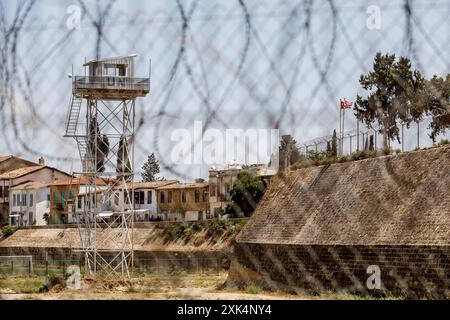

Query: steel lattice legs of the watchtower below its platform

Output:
[75, 97, 135, 276]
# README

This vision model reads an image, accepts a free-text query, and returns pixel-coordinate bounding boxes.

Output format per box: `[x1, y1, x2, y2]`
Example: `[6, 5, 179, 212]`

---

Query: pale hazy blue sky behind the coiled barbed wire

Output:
[0, 0, 450, 181]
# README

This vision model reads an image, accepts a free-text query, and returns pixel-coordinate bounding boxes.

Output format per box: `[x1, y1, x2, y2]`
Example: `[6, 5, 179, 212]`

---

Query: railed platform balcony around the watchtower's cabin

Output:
[72, 76, 150, 98]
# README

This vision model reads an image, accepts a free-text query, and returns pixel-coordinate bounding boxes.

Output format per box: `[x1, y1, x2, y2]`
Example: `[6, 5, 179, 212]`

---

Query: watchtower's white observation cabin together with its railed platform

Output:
[72, 54, 150, 100]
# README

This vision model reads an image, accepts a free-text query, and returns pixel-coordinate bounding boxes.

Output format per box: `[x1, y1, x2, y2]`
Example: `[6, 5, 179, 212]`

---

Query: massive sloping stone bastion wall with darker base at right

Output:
[230, 147, 450, 297]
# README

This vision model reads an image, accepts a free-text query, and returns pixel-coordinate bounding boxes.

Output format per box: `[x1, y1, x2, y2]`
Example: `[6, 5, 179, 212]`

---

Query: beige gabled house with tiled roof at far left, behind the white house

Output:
[0, 159, 70, 226]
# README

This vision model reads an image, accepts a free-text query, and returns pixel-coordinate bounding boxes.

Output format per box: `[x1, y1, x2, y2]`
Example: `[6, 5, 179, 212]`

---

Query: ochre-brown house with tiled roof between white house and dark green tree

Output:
[156, 182, 210, 221]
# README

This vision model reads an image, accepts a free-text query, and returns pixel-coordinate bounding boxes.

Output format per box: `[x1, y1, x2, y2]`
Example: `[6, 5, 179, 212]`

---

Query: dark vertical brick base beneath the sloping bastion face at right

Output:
[228, 243, 450, 299]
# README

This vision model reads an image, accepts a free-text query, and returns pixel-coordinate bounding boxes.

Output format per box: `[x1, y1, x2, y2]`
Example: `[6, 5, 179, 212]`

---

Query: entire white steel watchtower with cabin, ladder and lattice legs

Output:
[65, 55, 150, 276]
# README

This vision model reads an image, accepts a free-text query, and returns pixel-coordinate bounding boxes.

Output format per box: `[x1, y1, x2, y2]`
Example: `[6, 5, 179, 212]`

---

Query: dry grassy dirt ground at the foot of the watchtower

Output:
[0, 272, 305, 300]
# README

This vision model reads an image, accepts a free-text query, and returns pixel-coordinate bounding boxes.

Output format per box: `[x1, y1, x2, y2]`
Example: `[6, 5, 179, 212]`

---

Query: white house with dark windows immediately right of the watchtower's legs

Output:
[112, 180, 178, 221]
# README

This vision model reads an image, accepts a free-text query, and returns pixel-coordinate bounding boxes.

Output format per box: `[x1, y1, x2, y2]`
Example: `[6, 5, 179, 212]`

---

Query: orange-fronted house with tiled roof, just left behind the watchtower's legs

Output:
[49, 177, 106, 224]
